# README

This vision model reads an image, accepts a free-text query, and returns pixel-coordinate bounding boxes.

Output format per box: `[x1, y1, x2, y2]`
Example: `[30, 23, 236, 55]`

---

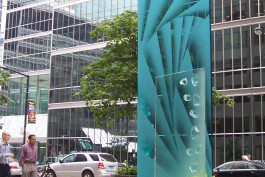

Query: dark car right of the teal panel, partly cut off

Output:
[213, 161, 265, 177]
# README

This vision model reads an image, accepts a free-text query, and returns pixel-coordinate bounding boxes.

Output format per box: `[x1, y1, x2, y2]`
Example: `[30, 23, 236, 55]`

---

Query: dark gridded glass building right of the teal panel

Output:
[211, 0, 265, 166]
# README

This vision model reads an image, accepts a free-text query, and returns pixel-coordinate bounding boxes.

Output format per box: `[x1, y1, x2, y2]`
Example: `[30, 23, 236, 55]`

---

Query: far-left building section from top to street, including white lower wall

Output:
[0, 0, 53, 162]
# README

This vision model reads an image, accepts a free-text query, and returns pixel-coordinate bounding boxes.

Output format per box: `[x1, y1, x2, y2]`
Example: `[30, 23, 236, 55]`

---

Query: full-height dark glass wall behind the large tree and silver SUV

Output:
[47, 0, 137, 162]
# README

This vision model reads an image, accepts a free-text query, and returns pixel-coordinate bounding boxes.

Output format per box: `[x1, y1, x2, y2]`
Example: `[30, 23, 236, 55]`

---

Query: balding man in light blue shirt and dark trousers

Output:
[0, 131, 14, 177]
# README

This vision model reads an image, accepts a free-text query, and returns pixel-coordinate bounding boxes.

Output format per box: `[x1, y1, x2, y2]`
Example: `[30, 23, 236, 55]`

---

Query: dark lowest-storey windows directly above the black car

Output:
[211, 95, 265, 166]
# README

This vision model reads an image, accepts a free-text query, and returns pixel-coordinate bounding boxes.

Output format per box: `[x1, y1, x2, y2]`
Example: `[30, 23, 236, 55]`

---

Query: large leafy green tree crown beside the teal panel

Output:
[78, 11, 138, 122]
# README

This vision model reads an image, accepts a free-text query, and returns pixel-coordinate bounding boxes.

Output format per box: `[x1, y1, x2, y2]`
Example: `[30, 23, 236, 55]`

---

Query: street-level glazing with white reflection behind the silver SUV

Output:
[48, 108, 137, 161]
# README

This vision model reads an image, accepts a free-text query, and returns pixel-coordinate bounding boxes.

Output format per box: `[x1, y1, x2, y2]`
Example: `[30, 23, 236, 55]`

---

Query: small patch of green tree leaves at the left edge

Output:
[0, 68, 13, 107]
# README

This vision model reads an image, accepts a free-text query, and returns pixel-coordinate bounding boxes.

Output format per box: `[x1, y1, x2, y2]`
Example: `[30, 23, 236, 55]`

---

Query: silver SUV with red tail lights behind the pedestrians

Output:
[48, 152, 118, 177]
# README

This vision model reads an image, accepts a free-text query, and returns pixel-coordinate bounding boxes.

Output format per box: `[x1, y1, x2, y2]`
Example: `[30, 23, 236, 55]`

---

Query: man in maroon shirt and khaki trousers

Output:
[19, 134, 37, 177]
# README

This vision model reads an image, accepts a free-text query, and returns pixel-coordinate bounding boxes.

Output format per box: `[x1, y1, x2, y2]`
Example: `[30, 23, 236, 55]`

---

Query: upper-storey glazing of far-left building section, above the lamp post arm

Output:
[4, 1, 53, 72]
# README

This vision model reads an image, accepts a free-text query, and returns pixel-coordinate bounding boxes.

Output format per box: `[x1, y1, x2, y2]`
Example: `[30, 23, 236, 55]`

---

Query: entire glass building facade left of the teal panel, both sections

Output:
[1, 0, 137, 161]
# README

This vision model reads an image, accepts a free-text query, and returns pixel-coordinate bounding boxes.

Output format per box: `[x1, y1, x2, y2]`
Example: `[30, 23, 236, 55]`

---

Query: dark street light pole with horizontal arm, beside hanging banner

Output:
[0, 66, 29, 144]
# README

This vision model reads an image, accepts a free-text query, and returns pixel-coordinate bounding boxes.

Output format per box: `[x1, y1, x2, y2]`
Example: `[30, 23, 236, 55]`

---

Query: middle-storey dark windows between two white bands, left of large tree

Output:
[50, 49, 103, 103]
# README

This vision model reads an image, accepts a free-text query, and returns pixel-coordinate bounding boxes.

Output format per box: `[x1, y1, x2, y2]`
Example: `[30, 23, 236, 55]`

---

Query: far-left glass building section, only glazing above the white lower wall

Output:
[0, 0, 53, 116]
